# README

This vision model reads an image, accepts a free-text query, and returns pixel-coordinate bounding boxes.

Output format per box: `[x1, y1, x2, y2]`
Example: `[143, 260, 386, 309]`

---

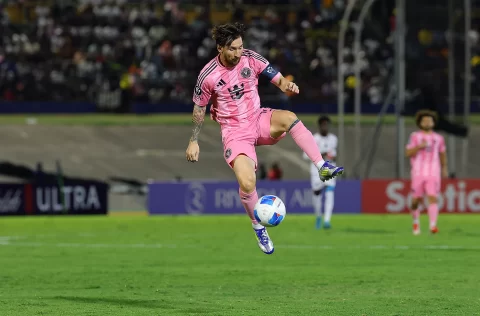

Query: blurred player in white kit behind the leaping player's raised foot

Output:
[303, 116, 338, 229]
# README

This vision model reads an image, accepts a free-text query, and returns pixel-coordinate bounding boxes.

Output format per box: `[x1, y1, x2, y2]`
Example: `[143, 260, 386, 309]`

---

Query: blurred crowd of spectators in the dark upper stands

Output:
[0, 0, 480, 113]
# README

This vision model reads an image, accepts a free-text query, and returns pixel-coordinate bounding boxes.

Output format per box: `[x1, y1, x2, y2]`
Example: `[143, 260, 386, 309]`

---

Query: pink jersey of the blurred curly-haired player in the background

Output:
[407, 131, 446, 178]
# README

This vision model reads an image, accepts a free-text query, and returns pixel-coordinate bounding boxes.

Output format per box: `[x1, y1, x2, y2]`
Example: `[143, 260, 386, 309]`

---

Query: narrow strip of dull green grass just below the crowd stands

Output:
[0, 113, 480, 125]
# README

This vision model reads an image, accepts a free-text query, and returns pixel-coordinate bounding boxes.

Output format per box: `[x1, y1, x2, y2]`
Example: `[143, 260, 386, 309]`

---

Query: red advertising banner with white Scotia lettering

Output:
[362, 179, 480, 214]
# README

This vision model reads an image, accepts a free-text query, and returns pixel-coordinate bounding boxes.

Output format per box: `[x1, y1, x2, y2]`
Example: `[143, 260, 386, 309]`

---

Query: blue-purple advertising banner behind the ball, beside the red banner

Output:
[148, 180, 362, 214]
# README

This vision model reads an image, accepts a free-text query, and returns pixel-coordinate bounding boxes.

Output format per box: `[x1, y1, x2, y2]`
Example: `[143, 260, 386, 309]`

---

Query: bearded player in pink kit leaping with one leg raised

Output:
[186, 23, 343, 254]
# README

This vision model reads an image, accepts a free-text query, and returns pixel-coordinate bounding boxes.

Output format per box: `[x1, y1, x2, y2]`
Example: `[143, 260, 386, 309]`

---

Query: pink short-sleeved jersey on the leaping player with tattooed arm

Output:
[193, 49, 280, 130]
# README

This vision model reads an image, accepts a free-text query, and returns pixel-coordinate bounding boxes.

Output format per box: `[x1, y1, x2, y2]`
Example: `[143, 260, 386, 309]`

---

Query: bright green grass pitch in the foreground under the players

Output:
[0, 215, 480, 316]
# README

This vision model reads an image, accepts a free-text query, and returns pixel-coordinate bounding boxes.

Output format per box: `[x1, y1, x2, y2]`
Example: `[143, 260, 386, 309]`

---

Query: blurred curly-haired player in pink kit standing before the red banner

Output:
[406, 110, 448, 235]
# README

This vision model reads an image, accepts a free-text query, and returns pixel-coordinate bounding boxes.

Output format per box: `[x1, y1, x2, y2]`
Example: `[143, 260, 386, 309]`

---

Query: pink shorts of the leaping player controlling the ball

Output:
[222, 108, 286, 170]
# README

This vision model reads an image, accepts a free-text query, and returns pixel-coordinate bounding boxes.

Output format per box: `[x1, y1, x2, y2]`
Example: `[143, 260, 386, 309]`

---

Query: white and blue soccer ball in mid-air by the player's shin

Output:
[253, 195, 287, 227]
